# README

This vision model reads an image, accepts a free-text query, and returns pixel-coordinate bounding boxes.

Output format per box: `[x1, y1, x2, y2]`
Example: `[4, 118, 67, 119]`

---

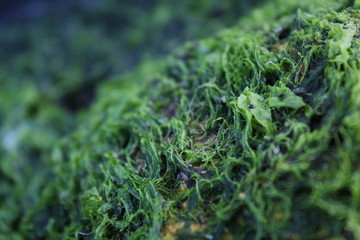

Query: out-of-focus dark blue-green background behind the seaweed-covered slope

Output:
[0, 0, 260, 236]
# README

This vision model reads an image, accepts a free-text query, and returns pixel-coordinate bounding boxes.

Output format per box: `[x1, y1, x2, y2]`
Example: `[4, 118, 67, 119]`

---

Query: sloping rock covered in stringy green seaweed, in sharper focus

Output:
[49, 2, 360, 239]
